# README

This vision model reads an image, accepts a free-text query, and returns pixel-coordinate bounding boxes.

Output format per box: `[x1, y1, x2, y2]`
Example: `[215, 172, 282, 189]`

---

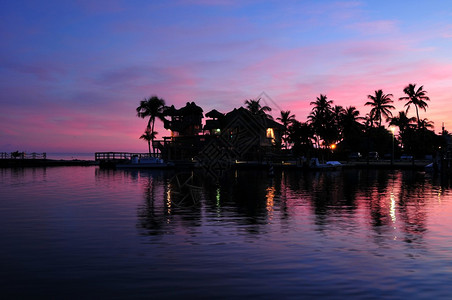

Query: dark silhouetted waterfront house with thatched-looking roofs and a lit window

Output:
[158, 102, 284, 161]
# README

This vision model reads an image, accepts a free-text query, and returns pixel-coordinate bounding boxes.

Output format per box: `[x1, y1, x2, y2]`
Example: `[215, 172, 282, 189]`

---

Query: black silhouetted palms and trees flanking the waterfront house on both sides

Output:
[136, 84, 443, 158]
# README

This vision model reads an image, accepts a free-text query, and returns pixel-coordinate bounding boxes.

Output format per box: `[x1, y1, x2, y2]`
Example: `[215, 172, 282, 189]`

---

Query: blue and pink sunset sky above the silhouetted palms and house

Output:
[0, 0, 452, 152]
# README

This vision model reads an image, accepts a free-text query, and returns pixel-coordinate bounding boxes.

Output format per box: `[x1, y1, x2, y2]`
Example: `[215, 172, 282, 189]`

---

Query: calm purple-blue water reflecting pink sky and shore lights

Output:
[0, 167, 452, 299]
